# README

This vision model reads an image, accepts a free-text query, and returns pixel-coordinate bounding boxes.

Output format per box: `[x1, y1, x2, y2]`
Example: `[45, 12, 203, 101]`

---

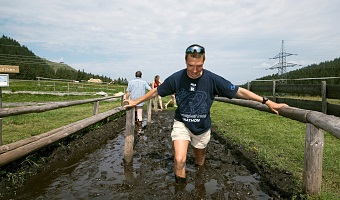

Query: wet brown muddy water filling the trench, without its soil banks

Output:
[11, 111, 272, 199]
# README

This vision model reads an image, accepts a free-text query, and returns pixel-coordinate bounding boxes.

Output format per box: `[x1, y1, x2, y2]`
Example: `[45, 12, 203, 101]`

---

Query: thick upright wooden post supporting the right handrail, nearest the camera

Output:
[302, 123, 324, 194]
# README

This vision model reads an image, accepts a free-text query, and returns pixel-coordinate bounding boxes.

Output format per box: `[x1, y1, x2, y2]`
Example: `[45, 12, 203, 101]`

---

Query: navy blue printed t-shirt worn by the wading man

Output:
[157, 69, 238, 135]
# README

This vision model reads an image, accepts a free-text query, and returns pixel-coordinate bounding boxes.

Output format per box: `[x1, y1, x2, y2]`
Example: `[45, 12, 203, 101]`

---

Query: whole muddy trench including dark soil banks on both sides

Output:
[0, 111, 296, 199]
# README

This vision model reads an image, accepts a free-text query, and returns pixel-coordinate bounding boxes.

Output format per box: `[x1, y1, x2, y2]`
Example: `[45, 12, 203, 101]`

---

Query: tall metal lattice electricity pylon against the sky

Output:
[269, 40, 297, 84]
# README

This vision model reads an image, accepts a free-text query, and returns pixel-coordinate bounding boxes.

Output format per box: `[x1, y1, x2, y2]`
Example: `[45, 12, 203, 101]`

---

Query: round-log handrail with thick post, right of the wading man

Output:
[215, 97, 340, 194]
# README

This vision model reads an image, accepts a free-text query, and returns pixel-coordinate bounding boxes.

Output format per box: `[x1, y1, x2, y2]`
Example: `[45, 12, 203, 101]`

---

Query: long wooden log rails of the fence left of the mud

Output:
[0, 96, 124, 167]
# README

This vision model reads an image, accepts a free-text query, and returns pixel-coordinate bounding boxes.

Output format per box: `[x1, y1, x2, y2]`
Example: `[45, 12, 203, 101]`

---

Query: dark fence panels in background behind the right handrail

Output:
[247, 80, 340, 117]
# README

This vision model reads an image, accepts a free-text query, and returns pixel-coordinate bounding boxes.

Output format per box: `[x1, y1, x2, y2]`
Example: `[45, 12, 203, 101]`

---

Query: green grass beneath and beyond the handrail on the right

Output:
[211, 102, 340, 199]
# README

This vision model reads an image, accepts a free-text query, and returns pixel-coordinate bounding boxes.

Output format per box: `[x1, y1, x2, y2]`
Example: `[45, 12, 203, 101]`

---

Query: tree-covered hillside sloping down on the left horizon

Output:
[0, 35, 128, 85]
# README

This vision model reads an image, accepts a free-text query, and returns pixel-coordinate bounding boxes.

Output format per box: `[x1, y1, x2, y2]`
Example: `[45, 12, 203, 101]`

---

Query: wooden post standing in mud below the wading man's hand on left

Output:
[124, 107, 135, 163]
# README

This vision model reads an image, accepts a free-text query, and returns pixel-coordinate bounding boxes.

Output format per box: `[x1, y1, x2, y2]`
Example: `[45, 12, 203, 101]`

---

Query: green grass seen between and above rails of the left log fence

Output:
[2, 94, 121, 144]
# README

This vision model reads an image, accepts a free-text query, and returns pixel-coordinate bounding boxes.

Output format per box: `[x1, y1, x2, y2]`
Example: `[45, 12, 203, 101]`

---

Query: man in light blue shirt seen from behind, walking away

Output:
[125, 71, 151, 133]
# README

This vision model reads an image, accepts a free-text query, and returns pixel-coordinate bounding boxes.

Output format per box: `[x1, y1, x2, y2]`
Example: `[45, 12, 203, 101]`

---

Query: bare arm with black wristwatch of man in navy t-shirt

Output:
[236, 87, 286, 114]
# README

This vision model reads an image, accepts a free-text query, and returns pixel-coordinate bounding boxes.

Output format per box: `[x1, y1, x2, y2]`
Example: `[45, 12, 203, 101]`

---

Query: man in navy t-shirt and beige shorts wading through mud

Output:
[125, 44, 286, 183]
